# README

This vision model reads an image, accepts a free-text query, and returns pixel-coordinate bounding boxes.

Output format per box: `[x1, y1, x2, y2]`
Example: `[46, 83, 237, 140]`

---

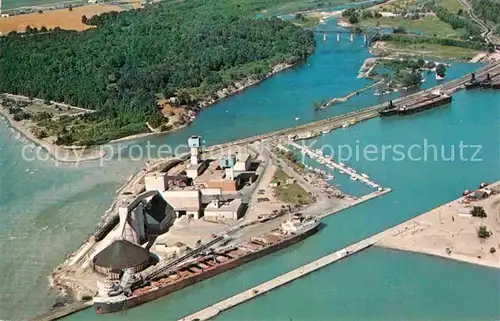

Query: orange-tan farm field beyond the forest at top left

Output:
[0, 5, 123, 34]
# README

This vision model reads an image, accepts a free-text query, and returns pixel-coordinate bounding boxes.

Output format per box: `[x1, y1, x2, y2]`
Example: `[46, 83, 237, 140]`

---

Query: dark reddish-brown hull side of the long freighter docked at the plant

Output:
[94, 225, 319, 314]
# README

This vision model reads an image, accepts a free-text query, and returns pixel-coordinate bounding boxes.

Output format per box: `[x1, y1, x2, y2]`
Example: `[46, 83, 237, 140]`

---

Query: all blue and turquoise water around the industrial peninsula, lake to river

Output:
[0, 18, 500, 320]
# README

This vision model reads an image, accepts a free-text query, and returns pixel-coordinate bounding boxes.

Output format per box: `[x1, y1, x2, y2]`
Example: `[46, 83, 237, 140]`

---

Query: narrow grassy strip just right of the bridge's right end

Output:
[383, 42, 479, 60]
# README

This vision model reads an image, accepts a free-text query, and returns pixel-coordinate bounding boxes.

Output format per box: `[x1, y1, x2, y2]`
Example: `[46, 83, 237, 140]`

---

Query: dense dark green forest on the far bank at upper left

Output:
[0, 0, 315, 145]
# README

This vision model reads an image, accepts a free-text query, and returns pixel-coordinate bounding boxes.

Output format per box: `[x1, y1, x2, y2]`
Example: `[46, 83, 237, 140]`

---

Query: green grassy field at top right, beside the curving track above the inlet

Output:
[359, 16, 461, 37]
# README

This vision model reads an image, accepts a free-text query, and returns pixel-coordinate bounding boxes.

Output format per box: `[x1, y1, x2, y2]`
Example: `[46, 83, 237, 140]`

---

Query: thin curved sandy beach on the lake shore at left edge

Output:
[0, 105, 106, 163]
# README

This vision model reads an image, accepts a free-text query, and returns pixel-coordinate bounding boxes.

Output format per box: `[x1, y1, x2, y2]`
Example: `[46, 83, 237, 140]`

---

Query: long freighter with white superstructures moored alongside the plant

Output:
[94, 214, 320, 314]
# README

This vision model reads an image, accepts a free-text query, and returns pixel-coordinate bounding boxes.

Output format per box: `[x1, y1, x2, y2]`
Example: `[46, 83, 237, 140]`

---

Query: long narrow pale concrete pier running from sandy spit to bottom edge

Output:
[178, 233, 383, 321]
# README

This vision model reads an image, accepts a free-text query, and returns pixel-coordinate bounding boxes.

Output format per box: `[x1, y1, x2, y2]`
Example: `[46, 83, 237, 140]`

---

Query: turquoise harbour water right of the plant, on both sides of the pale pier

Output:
[63, 91, 500, 320]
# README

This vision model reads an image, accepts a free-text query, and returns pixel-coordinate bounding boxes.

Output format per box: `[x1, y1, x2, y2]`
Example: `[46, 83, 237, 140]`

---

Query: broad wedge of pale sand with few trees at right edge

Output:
[377, 182, 500, 268]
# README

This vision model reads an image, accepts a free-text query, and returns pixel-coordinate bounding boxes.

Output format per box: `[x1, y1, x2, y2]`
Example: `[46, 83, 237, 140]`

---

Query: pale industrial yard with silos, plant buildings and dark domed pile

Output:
[52, 136, 366, 300]
